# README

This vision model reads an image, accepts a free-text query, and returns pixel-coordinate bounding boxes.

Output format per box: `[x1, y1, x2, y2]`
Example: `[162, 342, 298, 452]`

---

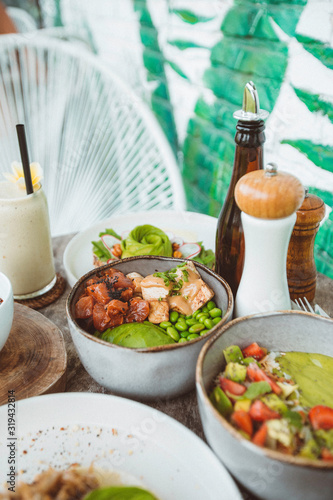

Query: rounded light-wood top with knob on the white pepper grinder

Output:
[235, 163, 304, 219]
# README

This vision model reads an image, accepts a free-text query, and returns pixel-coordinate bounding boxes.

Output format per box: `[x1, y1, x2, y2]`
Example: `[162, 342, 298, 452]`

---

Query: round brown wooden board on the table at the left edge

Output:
[0, 303, 67, 405]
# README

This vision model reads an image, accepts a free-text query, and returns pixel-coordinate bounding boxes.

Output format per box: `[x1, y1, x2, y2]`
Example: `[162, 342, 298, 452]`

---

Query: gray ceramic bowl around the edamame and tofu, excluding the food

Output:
[66, 256, 234, 400]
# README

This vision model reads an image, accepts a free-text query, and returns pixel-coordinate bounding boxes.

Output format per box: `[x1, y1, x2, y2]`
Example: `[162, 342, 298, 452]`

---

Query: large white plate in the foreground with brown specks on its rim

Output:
[0, 393, 242, 500]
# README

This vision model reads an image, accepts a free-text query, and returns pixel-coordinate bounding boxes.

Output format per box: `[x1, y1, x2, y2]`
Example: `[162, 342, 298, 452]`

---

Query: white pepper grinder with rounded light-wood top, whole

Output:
[235, 163, 304, 317]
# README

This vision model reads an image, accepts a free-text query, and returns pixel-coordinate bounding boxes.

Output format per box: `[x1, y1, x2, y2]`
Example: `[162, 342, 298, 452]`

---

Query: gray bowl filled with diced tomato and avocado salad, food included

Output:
[196, 311, 333, 499]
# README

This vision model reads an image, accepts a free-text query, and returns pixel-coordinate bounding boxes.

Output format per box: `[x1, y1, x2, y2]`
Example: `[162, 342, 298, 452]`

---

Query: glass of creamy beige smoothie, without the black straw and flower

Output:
[0, 181, 55, 298]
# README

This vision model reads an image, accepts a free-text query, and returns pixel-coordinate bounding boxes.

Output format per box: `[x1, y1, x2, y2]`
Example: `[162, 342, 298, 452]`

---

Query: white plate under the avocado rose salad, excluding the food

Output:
[63, 210, 217, 286]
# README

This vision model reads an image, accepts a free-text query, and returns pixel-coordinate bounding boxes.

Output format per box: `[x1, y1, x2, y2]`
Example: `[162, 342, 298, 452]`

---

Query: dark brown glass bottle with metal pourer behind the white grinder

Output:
[215, 82, 268, 297]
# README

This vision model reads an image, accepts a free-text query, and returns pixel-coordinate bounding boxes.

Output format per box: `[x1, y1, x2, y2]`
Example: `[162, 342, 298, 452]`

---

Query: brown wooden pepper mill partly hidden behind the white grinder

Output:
[287, 190, 325, 302]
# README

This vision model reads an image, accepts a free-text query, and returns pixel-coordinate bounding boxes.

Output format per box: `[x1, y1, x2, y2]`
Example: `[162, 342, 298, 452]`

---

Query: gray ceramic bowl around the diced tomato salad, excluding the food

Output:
[196, 311, 333, 500]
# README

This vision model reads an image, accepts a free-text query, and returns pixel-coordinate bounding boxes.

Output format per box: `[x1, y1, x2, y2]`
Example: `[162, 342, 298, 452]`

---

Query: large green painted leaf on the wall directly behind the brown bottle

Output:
[183, 0, 307, 216]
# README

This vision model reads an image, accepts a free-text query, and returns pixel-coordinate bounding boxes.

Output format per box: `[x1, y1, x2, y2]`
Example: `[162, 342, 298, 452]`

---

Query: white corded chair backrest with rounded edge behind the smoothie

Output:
[0, 35, 185, 235]
